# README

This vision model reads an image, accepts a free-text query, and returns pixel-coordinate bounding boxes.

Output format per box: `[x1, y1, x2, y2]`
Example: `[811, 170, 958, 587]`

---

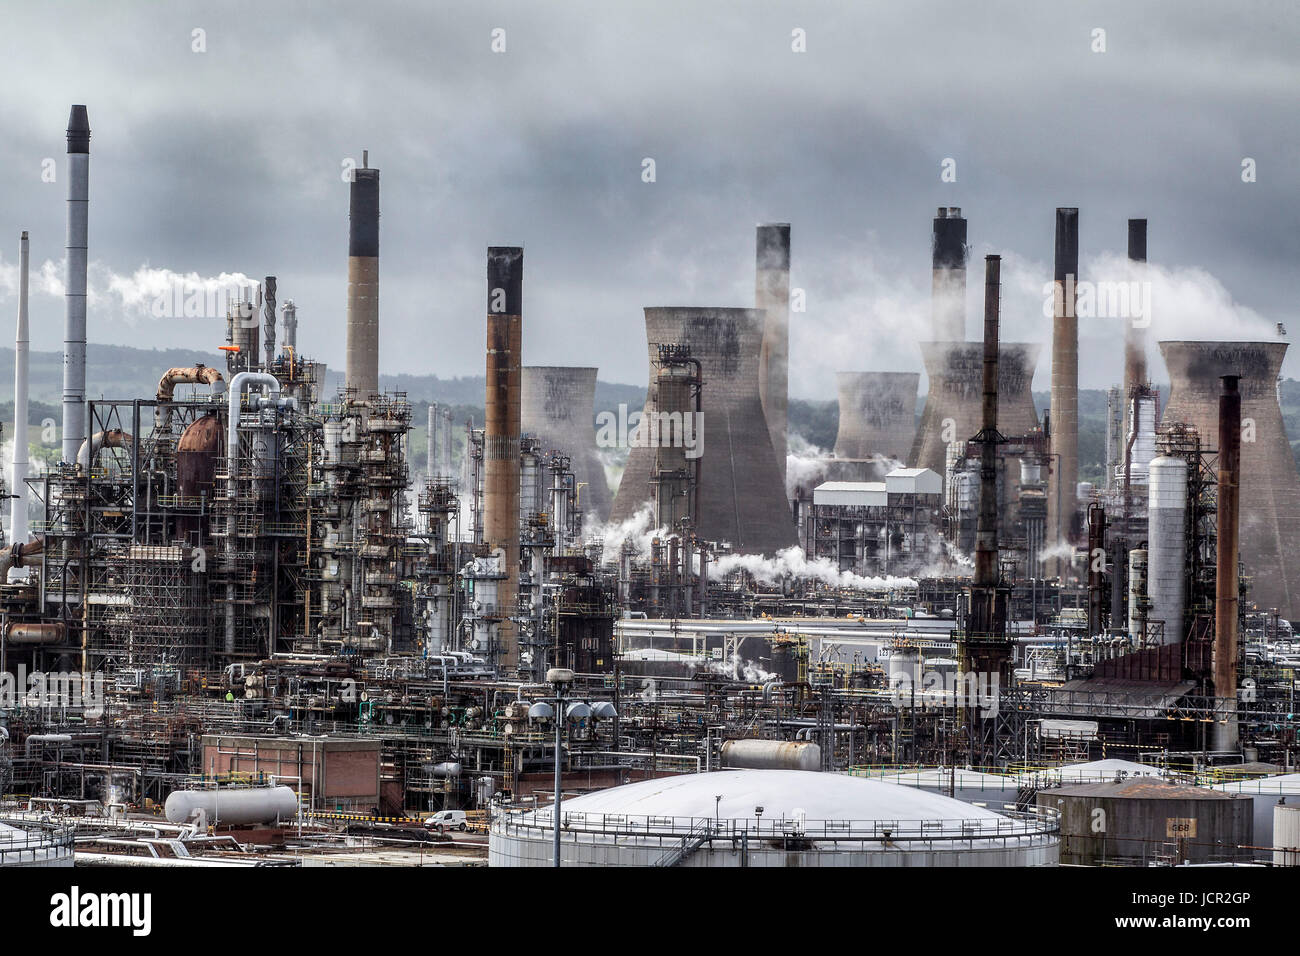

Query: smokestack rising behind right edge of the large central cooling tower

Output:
[754, 222, 790, 481]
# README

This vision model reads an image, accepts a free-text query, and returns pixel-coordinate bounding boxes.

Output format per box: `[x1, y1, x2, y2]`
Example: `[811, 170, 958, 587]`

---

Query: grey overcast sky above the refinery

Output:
[0, 0, 1300, 398]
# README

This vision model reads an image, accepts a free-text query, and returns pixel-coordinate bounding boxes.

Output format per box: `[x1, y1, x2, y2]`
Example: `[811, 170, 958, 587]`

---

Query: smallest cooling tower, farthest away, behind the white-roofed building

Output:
[835, 372, 920, 462]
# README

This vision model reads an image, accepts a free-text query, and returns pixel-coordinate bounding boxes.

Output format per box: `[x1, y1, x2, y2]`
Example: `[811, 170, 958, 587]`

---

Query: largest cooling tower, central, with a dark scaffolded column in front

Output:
[611, 307, 797, 554]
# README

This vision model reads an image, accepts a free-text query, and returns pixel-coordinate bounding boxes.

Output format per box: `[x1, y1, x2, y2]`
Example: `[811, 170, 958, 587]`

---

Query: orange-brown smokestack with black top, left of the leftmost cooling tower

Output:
[484, 246, 524, 672]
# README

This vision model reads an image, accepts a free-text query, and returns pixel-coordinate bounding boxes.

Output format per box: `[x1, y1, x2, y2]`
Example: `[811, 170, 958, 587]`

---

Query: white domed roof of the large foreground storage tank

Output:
[543, 770, 1005, 822]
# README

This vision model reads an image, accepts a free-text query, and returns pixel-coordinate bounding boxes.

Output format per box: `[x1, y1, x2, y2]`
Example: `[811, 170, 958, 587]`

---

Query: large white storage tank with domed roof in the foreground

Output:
[488, 770, 1060, 866]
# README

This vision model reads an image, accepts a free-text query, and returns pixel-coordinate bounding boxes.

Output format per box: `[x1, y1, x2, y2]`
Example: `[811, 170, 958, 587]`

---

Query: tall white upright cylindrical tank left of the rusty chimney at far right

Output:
[1147, 455, 1187, 644]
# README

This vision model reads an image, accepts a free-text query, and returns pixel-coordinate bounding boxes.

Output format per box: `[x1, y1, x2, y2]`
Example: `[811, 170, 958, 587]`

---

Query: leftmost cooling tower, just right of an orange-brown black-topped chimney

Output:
[521, 365, 612, 522]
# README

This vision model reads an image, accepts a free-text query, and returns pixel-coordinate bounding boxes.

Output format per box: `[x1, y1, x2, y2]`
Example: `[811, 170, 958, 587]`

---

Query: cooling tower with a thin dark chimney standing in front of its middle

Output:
[907, 342, 1039, 475]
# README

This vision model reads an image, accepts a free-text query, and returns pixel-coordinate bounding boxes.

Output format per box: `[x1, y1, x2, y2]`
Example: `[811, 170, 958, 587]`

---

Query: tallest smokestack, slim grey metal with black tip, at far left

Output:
[64, 107, 90, 462]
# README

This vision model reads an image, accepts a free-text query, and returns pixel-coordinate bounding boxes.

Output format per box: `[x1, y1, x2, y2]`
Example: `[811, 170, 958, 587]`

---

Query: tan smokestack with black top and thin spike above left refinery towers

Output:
[346, 152, 380, 399]
